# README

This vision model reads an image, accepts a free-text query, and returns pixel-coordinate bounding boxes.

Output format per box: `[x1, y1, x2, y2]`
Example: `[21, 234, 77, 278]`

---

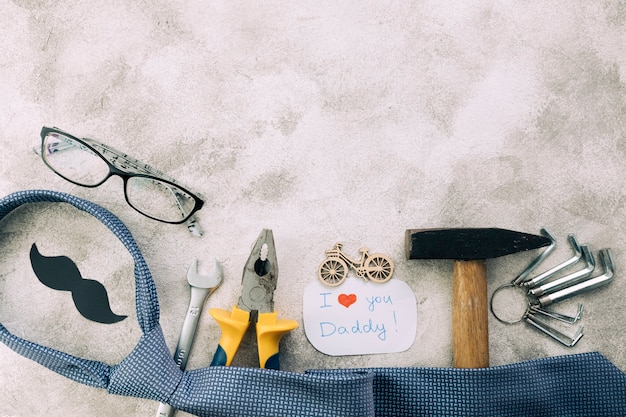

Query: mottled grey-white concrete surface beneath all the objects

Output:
[0, 0, 626, 417]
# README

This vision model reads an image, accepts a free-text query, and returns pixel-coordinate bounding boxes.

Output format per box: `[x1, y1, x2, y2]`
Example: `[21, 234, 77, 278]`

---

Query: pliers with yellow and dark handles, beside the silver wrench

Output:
[209, 229, 298, 369]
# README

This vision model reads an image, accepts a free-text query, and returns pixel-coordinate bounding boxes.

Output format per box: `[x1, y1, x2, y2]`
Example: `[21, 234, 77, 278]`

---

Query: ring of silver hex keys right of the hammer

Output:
[490, 229, 615, 347]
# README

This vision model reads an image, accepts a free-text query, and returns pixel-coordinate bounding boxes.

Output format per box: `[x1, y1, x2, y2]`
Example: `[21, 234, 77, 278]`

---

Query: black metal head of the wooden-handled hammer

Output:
[405, 228, 550, 260]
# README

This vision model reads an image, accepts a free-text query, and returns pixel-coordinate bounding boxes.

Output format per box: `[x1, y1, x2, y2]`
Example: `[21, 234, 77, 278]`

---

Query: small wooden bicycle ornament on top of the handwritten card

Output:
[318, 243, 393, 287]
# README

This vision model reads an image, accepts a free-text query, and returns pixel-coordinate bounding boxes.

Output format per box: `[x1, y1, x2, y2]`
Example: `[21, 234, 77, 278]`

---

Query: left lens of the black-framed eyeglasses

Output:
[41, 132, 109, 186]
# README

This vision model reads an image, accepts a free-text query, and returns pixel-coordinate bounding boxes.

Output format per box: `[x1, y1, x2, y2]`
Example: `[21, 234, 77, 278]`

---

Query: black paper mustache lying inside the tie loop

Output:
[30, 243, 127, 324]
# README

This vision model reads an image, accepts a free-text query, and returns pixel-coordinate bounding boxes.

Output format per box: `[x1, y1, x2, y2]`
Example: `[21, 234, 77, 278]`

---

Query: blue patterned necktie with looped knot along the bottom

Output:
[0, 190, 626, 417]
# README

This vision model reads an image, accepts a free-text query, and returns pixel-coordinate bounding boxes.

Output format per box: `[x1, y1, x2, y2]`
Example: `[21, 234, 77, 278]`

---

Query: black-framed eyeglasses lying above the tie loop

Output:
[36, 126, 204, 236]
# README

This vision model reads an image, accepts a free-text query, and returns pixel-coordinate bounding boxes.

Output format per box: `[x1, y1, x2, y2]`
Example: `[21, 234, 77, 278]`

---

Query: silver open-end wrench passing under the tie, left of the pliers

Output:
[156, 259, 224, 417]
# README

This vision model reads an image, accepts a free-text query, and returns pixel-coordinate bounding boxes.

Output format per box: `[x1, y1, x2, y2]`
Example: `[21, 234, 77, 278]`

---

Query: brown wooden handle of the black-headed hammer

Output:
[452, 260, 489, 368]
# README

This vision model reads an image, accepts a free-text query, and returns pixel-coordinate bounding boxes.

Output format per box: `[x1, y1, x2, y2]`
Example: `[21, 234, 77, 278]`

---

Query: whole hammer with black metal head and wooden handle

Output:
[405, 228, 551, 368]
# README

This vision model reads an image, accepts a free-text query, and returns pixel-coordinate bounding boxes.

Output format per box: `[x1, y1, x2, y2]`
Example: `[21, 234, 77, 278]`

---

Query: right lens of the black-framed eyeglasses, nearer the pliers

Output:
[126, 177, 196, 222]
